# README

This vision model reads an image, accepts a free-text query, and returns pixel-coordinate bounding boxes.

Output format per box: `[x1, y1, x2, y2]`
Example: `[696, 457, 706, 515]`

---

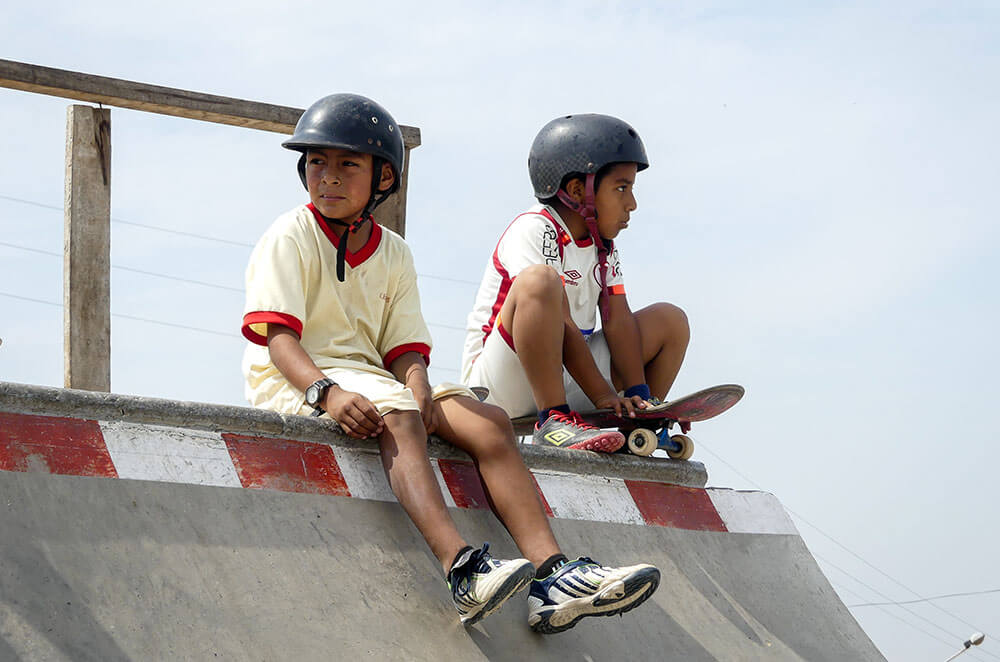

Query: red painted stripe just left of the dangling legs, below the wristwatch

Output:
[222, 433, 351, 496]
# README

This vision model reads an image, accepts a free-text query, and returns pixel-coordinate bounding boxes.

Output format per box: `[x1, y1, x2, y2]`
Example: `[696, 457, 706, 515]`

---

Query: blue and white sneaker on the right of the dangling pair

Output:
[528, 557, 660, 634]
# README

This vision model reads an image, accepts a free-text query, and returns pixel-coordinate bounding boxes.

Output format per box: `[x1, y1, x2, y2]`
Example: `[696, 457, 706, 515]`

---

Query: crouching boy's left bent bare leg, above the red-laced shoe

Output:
[500, 265, 566, 410]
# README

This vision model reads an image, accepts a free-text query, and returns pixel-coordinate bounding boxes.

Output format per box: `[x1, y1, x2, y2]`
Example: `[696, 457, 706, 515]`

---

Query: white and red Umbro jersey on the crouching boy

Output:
[462, 204, 625, 382]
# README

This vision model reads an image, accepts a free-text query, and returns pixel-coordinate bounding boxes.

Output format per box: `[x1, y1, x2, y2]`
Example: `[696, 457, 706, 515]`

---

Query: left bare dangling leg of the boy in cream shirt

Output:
[379, 411, 465, 574]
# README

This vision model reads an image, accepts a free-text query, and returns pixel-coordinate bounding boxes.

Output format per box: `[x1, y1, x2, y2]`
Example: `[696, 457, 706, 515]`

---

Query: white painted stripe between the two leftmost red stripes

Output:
[99, 421, 241, 487]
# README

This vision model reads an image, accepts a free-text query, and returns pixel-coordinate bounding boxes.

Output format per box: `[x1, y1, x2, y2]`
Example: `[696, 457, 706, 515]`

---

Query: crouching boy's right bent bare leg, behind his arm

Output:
[612, 303, 691, 400]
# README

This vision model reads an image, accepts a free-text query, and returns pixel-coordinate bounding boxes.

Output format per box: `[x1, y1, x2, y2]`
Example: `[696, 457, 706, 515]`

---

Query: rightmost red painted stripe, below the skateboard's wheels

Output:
[625, 479, 727, 531]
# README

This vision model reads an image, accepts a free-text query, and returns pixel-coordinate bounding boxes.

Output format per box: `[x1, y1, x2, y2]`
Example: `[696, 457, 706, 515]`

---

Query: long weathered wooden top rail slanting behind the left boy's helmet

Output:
[0, 59, 420, 149]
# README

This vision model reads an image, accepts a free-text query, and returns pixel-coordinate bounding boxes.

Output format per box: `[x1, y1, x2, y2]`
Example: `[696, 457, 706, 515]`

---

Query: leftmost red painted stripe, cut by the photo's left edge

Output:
[0, 412, 118, 478]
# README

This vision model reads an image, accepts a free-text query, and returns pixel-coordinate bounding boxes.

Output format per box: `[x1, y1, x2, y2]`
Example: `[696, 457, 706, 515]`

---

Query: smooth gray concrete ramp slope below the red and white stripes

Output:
[0, 471, 882, 662]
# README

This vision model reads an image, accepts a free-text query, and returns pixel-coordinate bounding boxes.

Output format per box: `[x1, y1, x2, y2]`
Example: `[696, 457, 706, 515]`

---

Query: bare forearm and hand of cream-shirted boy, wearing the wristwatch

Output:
[267, 324, 384, 439]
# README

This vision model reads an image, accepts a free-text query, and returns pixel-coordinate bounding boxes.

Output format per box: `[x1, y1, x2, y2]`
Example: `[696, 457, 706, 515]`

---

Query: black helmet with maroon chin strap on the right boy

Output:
[528, 113, 649, 319]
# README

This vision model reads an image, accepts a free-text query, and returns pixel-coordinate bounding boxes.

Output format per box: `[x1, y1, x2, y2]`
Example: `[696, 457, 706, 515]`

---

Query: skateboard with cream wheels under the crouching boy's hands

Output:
[512, 384, 744, 460]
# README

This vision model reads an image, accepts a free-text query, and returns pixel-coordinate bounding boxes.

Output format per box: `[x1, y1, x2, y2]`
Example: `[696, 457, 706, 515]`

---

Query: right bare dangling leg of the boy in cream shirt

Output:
[434, 396, 559, 567]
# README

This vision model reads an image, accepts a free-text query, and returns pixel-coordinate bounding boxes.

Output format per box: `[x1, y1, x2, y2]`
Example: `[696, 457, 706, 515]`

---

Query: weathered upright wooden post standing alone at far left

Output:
[63, 105, 111, 392]
